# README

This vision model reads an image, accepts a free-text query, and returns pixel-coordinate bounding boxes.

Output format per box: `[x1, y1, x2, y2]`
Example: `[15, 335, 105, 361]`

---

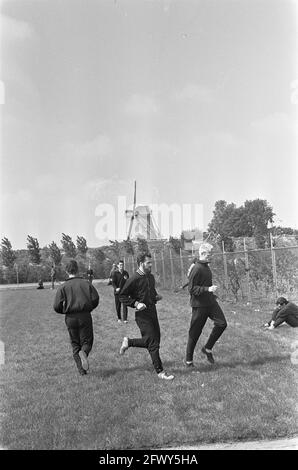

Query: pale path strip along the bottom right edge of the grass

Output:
[162, 436, 298, 450]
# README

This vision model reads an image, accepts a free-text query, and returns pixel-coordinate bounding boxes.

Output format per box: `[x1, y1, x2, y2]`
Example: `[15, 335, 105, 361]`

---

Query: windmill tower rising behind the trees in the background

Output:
[125, 181, 161, 240]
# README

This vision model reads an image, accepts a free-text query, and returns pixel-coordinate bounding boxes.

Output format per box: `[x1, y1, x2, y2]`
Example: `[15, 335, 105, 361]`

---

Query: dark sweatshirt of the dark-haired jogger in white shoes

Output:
[119, 269, 158, 308]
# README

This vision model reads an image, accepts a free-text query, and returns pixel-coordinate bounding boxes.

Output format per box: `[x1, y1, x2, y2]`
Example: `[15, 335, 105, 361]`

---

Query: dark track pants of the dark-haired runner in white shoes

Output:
[128, 305, 163, 373]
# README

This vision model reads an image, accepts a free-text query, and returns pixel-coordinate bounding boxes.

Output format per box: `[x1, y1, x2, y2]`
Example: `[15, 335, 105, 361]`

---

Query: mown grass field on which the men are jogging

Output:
[0, 284, 298, 449]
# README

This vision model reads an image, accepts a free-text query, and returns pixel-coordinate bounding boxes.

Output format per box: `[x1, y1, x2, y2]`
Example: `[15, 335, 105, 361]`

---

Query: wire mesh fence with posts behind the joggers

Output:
[124, 246, 298, 301]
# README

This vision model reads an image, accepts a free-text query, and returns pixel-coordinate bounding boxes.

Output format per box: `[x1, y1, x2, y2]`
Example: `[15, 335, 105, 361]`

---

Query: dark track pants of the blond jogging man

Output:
[186, 302, 227, 361]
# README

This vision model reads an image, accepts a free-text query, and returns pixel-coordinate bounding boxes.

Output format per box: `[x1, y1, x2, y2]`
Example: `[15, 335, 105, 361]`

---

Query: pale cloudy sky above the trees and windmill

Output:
[0, 0, 298, 249]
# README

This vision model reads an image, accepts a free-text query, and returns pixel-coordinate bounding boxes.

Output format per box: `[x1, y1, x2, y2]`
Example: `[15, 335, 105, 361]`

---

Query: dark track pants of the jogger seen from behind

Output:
[65, 312, 93, 357]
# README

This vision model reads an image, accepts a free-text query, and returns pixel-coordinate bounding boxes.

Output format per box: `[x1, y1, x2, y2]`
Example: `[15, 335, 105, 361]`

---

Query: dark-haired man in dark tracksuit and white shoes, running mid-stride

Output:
[120, 253, 174, 380]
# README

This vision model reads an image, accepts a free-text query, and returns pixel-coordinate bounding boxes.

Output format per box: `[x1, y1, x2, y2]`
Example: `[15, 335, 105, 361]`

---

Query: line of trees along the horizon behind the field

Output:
[0, 199, 298, 282]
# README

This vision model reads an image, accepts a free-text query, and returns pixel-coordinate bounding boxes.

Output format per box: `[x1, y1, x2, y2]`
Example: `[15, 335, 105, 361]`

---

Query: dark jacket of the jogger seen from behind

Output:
[54, 277, 99, 314]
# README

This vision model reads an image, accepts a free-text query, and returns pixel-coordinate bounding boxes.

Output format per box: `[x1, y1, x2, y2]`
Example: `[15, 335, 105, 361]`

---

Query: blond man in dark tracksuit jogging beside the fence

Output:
[186, 243, 227, 367]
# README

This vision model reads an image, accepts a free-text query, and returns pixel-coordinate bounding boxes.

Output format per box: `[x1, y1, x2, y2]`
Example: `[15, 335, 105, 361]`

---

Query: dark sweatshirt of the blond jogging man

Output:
[188, 261, 216, 307]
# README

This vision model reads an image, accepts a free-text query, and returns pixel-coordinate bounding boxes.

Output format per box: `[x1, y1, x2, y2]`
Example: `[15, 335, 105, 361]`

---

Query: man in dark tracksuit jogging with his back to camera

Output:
[54, 260, 99, 375]
